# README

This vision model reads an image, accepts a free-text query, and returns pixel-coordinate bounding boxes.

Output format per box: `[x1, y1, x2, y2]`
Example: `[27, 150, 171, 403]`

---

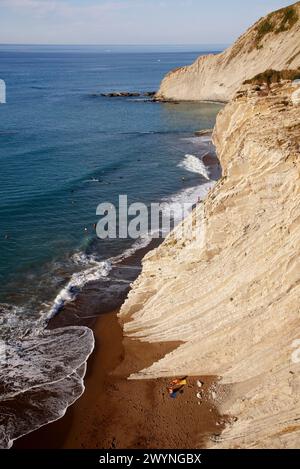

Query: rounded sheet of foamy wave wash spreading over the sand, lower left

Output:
[0, 327, 94, 448]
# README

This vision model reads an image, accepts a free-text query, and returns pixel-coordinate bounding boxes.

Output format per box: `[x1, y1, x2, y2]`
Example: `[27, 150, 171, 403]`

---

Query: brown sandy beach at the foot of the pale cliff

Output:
[15, 312, 222, 449]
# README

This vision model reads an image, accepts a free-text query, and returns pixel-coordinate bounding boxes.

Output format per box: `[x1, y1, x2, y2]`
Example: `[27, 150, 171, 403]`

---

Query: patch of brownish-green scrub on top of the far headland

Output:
[254, 5, 299, 49]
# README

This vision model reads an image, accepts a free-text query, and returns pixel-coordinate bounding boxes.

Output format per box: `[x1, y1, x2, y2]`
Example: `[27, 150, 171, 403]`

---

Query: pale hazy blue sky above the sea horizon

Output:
[0, 0, 293, 44]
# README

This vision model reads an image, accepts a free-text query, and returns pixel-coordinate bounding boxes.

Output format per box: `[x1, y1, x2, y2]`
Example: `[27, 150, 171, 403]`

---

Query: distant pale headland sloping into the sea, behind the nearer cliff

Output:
[156, 2, 300, 101]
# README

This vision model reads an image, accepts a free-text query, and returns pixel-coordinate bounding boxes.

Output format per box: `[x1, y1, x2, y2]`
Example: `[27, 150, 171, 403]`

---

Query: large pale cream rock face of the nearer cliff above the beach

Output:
[120, 82, 300, 448]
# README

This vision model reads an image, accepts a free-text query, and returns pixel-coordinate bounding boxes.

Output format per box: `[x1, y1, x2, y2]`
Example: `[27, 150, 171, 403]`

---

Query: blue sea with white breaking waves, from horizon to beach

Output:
[0, 45, 221, 447]
